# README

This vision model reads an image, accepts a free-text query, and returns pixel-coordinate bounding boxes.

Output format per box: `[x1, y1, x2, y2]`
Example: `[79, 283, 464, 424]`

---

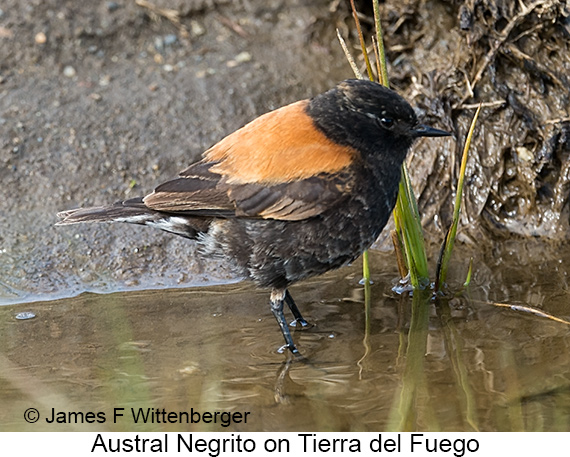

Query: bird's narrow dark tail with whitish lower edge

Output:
[56, 198, 205, 238]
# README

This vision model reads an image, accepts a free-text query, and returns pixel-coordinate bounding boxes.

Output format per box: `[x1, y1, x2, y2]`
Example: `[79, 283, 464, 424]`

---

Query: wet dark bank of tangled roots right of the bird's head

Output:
[365, 0, 570, 239]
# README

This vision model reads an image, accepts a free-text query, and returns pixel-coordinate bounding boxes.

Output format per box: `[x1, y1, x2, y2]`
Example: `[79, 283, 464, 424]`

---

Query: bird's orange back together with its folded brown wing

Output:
[144, 100, 356, 220]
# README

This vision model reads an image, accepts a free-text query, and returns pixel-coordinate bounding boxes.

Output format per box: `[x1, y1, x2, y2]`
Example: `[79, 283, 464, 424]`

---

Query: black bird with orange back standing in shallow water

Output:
[57, 79, 450, 355]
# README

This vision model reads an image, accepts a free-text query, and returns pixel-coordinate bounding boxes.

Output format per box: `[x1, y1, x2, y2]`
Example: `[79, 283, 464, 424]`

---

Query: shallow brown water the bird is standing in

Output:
[0, 243, 570, 431]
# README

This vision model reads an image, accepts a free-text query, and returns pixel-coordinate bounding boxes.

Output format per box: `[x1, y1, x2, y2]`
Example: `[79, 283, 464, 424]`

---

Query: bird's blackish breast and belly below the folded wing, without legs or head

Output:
[201, 162, 399, 288]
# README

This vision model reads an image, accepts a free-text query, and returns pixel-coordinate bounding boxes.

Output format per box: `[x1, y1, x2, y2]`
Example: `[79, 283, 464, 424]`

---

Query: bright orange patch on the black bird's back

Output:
[204, 100, 356, 184]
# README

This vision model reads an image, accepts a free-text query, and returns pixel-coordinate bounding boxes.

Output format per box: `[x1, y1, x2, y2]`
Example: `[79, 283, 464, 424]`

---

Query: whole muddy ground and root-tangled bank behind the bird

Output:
[0, 0, 570, 302]
